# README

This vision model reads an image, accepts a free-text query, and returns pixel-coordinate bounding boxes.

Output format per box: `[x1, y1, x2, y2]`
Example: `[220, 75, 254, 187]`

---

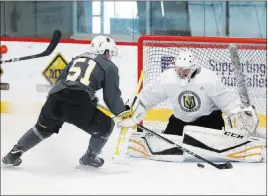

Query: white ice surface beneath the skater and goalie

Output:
[1, 114, 267, 195]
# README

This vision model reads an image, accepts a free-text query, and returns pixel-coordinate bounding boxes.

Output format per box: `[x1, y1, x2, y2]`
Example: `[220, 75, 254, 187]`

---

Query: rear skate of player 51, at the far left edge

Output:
[2, 145, 22, 166]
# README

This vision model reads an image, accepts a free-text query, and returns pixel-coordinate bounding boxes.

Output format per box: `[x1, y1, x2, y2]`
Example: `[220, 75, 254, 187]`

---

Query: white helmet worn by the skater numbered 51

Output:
[90, 35, 118, 59]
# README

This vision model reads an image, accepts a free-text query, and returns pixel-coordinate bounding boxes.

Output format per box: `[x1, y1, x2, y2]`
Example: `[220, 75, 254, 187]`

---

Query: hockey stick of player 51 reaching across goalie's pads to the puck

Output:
[137, 125, 233, 169]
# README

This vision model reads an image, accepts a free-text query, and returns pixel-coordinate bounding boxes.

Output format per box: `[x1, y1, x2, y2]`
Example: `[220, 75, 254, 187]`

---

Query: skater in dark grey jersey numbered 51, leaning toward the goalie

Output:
[2, 35, 133, 167]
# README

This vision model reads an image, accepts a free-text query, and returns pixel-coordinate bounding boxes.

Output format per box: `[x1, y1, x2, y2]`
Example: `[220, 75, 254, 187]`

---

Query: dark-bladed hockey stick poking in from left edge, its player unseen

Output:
[0, 30, 61, 64]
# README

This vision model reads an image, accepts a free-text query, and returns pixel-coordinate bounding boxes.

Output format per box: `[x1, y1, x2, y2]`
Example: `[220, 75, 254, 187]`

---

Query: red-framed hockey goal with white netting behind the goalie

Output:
[138, 36, 267, 135]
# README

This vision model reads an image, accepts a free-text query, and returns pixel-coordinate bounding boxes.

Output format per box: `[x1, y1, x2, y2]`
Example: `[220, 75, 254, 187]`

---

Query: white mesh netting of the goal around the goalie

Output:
[139, 37, 267, 134]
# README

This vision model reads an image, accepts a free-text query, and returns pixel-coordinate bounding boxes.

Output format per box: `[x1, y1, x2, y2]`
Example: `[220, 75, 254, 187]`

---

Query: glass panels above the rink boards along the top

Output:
[0, 0, 267, 41]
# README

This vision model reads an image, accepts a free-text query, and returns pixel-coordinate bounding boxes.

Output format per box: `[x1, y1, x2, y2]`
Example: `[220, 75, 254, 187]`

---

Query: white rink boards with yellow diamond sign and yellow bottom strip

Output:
[1, 41, 267, 132]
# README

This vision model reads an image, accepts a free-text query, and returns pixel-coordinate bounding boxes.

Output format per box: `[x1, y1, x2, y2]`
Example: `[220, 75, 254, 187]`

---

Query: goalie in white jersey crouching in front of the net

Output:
[119, 51, 264, 162]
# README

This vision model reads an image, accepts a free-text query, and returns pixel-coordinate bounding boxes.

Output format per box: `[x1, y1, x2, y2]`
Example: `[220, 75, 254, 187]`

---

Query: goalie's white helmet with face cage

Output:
[174, 50, 197, 86]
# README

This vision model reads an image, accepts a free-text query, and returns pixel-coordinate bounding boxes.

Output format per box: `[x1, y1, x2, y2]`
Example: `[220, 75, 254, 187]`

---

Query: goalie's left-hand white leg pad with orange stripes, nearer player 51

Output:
[127, 132, 184, 162]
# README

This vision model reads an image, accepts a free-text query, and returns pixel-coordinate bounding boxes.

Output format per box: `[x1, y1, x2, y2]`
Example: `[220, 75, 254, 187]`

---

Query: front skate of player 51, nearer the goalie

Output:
[79, 149, 104, 167]
